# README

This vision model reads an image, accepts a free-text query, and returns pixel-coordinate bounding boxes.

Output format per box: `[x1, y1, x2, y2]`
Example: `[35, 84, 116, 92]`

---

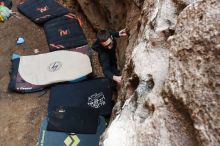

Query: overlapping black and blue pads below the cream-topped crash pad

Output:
[38, 78, 112, 146]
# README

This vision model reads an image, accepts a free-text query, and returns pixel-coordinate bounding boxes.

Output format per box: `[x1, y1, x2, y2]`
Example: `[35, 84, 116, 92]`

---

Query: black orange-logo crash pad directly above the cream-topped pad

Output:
[44, 13, 87, 51]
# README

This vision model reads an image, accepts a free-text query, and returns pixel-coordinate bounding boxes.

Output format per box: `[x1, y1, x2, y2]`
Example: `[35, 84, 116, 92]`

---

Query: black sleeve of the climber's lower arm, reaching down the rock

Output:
[100, 52, 114, 80]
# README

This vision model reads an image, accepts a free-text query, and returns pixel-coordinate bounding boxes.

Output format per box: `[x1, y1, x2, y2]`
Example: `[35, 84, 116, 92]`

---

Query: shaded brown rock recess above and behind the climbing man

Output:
[76, 0, 141, 67]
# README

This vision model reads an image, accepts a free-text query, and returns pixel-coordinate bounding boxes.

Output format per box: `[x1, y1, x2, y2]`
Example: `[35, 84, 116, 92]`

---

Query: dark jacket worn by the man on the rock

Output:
[92, 32, 119, 80]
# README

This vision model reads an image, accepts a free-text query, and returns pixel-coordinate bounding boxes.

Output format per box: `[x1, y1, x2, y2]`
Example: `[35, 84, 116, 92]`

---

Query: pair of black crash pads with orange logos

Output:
[18, 0, 89, 54]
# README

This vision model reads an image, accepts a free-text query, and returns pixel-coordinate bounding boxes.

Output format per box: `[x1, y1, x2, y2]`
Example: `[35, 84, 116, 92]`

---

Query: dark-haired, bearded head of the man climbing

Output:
[97, 30, 113, 49]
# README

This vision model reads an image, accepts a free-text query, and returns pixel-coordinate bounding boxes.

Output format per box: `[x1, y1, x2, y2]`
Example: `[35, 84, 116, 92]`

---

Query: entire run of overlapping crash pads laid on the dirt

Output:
[9, 0, 112, 146]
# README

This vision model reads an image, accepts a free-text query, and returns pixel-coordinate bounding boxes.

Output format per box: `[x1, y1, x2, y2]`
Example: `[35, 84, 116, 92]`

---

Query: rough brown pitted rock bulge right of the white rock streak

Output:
[165, 1, 220, 145]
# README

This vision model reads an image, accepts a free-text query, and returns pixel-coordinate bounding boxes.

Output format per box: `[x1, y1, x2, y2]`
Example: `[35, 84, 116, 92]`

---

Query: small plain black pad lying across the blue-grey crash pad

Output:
[47, 106, 98, 134]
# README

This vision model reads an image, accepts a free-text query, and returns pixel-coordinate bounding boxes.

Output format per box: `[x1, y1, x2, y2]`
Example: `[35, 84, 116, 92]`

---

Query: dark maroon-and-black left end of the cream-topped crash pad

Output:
[8, 58, 45, 93]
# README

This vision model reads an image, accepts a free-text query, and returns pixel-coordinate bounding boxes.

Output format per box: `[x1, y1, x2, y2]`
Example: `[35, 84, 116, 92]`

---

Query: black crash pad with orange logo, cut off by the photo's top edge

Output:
[18, 0, 69, 24]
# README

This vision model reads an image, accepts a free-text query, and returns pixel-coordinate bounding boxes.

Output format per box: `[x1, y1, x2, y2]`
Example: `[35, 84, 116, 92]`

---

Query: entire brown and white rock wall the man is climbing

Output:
[78, 0, 220, 146]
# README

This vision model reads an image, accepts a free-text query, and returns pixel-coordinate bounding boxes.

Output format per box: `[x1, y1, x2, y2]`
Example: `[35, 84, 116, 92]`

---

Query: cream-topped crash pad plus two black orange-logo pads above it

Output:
[9, 0, 92, 93]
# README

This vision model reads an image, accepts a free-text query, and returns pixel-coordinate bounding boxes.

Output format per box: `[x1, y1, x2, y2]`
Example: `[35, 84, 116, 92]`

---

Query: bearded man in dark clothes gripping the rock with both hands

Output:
[92, 29, 127, 84]
